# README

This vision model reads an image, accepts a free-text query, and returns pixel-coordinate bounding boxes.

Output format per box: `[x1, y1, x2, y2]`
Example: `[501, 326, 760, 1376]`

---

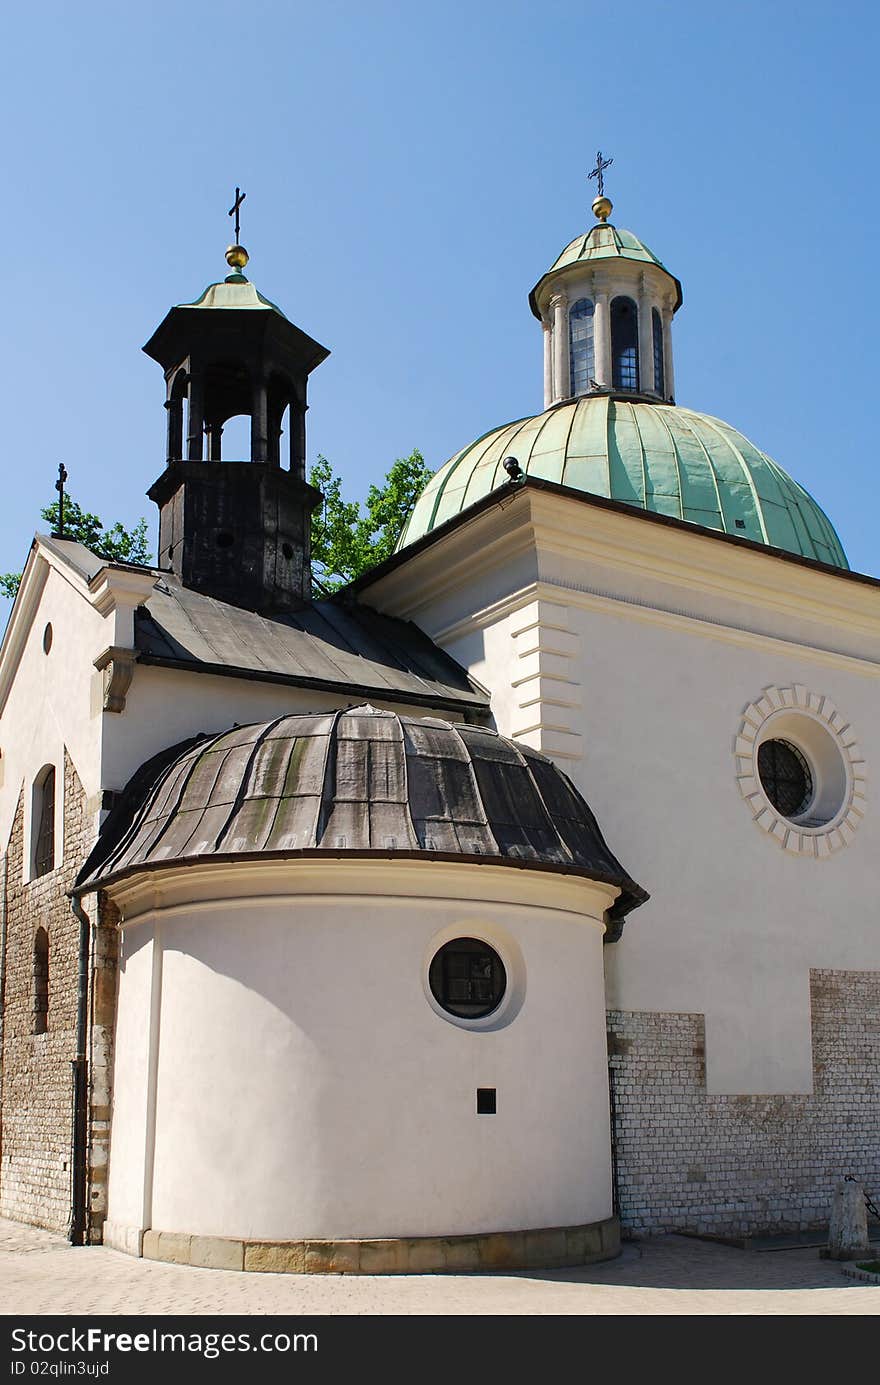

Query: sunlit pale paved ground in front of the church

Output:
[0, 1220, 880, 1316]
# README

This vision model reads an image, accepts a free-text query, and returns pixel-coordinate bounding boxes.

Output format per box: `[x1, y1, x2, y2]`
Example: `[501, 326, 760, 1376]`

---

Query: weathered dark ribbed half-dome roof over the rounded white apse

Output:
[73, 706, 647, 918]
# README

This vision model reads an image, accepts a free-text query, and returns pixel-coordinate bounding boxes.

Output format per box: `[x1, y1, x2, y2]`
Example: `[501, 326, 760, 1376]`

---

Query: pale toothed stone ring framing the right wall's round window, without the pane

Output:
[733, 683, 868, 860]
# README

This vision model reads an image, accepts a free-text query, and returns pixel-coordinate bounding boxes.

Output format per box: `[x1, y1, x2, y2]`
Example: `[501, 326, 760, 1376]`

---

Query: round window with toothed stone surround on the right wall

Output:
[734, 684, 866, 857]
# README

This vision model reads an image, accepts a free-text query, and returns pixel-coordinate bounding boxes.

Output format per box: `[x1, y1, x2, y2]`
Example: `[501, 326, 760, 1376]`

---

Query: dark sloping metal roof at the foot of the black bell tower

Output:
[134, 573, 489, 716]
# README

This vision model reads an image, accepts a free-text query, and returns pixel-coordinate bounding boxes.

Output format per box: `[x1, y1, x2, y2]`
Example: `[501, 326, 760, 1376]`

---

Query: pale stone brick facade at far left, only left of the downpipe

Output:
[0, 753, 106, 1231]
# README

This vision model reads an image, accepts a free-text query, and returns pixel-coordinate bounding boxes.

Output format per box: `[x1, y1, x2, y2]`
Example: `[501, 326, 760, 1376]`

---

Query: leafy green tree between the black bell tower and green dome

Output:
[309, 449, 432, 591]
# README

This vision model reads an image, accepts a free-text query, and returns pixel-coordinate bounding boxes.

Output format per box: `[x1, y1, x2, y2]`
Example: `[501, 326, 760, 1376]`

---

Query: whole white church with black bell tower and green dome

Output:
[0, 175, 880, 1273]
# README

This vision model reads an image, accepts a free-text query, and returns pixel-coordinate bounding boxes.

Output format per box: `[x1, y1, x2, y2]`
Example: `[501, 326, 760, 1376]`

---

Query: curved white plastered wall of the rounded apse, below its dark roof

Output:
[109, 859, 615, 1249]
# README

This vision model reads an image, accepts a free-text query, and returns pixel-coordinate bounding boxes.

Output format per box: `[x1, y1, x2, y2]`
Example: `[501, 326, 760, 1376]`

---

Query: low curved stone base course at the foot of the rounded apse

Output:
[104, 1216, 621, 1274]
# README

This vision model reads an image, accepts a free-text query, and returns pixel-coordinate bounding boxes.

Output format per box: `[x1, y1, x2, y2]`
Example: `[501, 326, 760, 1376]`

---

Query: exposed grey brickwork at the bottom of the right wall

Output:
[608, 971, 880, 1235]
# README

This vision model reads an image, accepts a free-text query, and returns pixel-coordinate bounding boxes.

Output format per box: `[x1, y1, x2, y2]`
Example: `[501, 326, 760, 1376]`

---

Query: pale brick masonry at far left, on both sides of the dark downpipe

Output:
[0, 753, 116, 1240]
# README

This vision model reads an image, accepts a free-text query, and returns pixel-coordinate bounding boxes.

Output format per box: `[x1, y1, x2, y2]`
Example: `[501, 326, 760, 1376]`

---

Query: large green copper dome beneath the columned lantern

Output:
[398, 395, 850, 568]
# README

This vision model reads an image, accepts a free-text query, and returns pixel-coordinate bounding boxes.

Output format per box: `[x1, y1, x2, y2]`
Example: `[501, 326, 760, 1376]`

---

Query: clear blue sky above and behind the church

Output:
[0, 0, 880, 603]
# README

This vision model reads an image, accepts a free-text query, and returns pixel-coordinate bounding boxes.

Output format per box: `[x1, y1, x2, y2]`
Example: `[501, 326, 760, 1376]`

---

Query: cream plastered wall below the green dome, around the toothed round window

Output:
[357, 494, 880, 1096]
